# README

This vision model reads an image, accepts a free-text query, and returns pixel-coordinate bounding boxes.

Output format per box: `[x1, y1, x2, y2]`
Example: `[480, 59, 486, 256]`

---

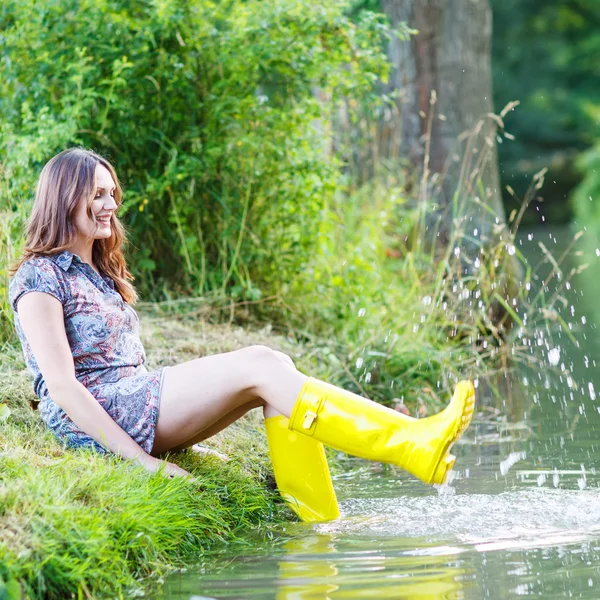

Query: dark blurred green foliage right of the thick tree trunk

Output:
[491, 0, 600, 222]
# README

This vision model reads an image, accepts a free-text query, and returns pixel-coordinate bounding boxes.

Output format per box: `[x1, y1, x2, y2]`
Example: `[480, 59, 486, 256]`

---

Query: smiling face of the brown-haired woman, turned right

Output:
[74, 164, 118, 239]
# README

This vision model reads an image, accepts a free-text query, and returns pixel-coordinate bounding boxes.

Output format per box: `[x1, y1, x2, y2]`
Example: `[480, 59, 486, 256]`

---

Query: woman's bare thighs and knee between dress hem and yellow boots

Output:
[152, 346, 307, 455]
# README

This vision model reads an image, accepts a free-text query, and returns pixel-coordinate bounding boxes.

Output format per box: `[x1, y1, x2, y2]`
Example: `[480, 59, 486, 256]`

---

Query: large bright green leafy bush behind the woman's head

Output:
[0, 0, 387, 328]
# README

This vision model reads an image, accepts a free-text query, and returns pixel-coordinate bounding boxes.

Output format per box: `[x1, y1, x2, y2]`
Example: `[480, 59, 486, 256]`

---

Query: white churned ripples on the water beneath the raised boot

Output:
[316, 488, 600, 549]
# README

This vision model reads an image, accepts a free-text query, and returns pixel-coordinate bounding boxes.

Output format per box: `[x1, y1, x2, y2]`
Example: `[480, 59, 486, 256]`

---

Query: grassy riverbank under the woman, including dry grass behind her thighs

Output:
[0, 312, 332, 598]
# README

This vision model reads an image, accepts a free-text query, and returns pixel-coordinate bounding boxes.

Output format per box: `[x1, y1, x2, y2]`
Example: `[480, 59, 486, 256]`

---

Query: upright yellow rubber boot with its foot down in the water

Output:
[265, 415, 340, 522]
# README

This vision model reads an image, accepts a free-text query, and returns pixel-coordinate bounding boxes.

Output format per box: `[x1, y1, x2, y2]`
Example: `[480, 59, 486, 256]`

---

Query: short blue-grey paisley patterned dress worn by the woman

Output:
[9, 250, 168, 453]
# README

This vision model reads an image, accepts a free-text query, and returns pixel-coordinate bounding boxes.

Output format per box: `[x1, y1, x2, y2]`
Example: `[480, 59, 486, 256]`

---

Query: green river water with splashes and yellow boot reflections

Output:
[157, 230, 600, 600]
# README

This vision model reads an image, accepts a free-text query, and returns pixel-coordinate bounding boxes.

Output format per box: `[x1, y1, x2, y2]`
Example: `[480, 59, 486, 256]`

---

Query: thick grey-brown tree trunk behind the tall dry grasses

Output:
[379, 0, 505, 248]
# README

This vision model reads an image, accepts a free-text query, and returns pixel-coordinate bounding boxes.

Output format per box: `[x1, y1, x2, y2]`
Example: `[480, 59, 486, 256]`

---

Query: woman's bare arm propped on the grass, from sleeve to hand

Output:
[18, 292, 188, 475]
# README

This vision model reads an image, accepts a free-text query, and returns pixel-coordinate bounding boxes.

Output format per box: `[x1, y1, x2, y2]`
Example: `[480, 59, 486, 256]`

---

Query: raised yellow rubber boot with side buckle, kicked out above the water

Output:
[289, 377, 475, 484]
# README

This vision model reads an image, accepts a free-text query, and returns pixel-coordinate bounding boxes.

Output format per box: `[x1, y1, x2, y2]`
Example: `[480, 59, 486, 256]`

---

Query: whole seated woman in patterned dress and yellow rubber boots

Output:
[9, 148, 474, 521]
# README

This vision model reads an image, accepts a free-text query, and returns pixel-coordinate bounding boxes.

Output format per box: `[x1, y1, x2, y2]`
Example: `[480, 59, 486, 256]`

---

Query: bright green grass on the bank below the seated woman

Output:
[0, 426, 282, 598]
